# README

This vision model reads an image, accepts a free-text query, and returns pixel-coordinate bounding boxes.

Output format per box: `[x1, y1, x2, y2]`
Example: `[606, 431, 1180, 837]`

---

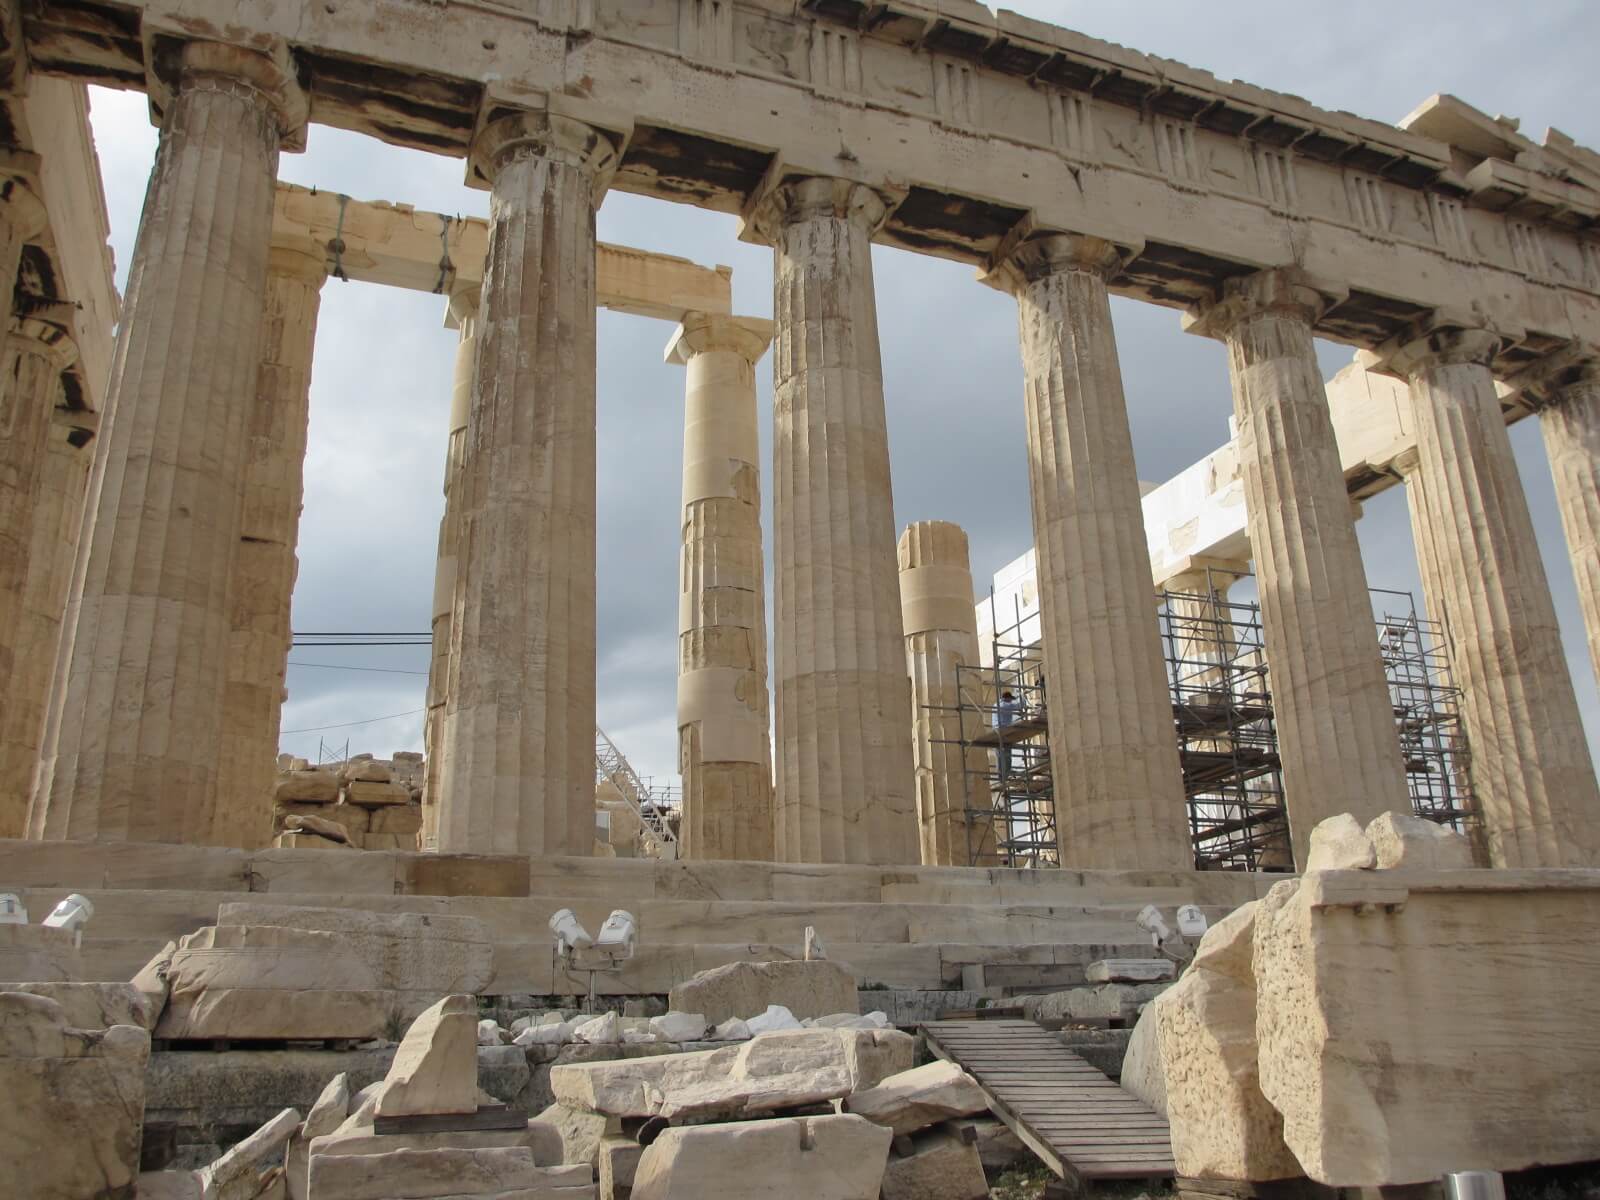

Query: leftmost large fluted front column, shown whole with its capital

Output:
[38, 42, 304, 842]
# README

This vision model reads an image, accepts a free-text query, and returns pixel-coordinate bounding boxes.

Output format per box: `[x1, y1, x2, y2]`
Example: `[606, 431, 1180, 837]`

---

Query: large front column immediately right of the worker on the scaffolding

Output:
[995, 234, 1194, 870]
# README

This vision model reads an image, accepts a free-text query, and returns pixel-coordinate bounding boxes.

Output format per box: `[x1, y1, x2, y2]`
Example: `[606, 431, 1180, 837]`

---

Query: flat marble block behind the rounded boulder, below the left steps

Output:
[218, 901, 494, 1011]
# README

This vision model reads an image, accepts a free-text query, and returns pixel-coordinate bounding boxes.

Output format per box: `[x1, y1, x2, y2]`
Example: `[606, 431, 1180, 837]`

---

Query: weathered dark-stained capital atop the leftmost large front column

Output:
[149, 38, 310, 150]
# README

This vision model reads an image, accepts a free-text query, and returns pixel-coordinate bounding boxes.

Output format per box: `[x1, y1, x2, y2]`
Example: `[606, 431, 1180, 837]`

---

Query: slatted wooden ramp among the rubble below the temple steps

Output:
[922, 1021, 1174, 1184]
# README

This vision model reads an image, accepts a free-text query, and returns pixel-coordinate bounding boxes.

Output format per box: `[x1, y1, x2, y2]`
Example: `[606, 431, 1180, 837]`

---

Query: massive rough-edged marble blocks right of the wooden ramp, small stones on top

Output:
[1122, 813, 1600, 1192]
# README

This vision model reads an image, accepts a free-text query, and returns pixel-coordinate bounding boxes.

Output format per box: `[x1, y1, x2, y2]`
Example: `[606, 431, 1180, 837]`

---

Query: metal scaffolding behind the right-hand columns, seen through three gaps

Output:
[931, 576, 1472, 870]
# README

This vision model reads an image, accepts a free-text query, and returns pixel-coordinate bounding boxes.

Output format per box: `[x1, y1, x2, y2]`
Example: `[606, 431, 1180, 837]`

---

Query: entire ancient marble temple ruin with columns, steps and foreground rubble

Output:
[0, 0, 1600, 1200]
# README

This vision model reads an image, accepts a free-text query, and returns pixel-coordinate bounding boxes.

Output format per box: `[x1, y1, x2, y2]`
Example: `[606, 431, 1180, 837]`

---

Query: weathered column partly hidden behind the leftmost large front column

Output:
[211, 240, 328, 850]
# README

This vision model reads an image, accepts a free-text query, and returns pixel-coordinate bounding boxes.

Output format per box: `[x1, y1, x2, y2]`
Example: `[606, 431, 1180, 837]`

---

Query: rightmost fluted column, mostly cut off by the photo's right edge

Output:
[1539, 362, 1600, 694]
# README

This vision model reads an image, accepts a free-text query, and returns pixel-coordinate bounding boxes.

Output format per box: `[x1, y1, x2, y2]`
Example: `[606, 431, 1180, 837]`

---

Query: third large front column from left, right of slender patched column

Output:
[752, 178, 920, 864]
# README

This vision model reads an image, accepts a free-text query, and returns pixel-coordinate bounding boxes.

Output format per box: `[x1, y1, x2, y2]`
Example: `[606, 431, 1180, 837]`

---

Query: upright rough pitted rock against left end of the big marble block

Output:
[1157, 904, 1302, 1181]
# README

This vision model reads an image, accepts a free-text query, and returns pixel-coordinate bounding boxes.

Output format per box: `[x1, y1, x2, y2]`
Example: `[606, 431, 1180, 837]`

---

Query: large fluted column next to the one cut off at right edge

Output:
[1386, 328, 1600, 867]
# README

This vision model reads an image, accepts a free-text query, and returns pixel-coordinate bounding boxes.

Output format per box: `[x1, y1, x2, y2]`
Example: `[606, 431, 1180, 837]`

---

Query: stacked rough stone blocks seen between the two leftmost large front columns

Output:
[272, 750, 424, 850]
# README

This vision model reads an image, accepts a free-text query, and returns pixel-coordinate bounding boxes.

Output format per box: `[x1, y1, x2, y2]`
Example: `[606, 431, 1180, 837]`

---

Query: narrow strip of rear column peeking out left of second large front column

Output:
[421, 286, 483, 850]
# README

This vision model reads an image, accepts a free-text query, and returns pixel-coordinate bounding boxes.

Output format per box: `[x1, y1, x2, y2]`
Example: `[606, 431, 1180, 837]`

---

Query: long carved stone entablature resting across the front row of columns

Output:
[24, 0, 1600, 368]
